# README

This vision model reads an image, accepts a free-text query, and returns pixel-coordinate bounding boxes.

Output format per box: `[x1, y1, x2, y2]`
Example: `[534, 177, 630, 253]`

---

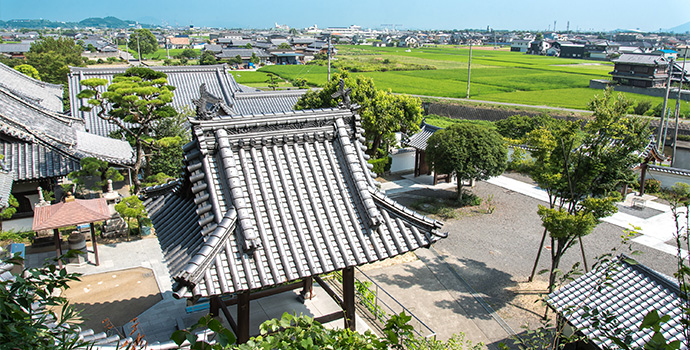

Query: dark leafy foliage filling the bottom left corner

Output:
[0, 253, 89, 350]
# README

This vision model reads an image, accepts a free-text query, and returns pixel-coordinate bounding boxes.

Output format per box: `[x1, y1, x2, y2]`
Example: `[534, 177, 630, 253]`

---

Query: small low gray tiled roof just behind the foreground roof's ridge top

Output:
[233, 90, 308, 115]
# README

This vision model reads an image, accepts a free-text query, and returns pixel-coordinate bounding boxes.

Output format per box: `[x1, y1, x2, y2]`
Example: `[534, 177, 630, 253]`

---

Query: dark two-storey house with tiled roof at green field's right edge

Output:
[609, 54, 669, 87]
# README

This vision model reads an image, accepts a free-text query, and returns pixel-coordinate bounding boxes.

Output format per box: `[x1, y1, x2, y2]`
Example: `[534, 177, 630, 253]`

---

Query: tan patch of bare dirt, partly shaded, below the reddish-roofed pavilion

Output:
[63, 267, 162, 332]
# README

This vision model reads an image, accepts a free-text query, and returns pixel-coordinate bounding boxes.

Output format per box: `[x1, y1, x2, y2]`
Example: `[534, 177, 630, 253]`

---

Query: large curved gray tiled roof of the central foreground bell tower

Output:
[147, 109, 445, 297]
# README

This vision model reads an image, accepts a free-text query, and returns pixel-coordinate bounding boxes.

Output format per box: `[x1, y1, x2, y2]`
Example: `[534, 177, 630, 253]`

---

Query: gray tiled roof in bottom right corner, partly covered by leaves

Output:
[547, 257, 684, 349]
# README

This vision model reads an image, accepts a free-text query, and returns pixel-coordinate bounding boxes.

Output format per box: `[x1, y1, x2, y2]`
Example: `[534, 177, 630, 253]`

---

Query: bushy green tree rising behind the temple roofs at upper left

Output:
[26, 37, 84, 85]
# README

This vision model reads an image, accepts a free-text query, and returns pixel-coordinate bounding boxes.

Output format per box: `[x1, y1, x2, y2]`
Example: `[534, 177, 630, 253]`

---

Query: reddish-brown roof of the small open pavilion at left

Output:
[32, 198, 111, 231]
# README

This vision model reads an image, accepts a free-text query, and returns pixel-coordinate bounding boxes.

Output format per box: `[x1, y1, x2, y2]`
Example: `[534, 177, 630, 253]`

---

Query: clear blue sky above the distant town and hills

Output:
[0, 0, 690, 31]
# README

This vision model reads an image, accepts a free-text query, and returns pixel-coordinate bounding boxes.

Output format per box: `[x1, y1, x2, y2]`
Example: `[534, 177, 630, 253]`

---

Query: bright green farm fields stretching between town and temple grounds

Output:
[260, 45, 690, 113]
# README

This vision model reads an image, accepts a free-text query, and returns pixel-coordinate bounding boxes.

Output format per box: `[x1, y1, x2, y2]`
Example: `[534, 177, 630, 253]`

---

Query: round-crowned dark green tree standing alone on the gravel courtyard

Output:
[426, 123, 508, 200]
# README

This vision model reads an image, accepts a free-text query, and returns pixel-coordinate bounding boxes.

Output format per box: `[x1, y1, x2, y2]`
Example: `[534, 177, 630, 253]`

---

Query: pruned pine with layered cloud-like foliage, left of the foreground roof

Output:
[77, 67, 177, 194]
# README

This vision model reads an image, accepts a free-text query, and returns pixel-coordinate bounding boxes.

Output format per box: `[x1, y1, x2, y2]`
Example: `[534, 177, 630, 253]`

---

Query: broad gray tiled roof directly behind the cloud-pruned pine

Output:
[69, 64, 239, 136]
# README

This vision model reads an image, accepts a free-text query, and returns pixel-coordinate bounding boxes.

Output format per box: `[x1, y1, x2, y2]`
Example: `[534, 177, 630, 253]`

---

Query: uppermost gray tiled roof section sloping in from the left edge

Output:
[0, 63, 62, 112]
